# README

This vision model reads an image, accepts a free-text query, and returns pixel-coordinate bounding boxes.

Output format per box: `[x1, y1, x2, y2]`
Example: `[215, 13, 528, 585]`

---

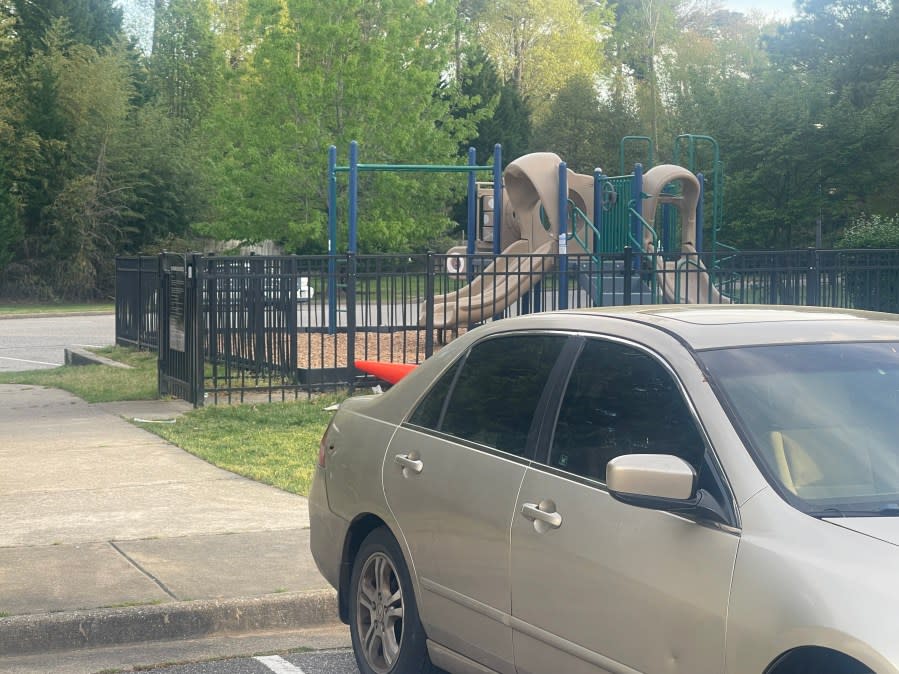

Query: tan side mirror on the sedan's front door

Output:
[606, 454, 728, 524]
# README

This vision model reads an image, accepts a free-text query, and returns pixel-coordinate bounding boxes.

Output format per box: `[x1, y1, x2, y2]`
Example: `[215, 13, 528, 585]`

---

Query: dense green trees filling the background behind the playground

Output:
[0, 0, 899, 288]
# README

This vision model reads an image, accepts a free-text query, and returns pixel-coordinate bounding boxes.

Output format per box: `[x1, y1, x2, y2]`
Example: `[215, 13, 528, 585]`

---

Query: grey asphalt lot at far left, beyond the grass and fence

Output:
[0, 314, 115, 372]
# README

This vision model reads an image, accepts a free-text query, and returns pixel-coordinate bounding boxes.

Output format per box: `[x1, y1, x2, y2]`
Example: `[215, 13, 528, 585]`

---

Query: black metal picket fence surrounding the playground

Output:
[116, 249, 899, 404]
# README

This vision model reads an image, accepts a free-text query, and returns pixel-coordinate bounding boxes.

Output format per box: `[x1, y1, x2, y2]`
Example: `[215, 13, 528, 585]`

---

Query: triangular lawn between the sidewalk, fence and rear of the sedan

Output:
[138, 394, 341, 496]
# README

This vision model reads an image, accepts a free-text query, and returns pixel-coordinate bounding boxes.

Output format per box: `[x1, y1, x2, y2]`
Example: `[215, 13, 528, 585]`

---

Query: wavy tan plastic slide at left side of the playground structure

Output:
[419, 239, 555, 329]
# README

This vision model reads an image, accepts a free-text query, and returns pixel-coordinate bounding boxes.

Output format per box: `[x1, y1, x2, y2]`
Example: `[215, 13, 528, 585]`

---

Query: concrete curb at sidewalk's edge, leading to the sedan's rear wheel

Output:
[0, 590, 338, 656]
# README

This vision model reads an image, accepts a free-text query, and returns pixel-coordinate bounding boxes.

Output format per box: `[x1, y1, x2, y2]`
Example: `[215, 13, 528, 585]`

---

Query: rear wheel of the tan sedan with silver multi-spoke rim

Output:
[349, 527, 439, 674]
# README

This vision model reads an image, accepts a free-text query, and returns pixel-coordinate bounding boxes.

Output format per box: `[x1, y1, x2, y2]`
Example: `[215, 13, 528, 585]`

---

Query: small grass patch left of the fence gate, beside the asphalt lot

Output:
[0, 346, 159, 403]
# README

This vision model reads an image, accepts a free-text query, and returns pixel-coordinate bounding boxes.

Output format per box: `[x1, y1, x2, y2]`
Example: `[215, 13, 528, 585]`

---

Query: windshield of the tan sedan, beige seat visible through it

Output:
[700, 342, 899, 517]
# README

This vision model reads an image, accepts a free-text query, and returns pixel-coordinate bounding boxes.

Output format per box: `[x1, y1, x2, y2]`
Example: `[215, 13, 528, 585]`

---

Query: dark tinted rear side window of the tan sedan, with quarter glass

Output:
[409, 334, 566, 456]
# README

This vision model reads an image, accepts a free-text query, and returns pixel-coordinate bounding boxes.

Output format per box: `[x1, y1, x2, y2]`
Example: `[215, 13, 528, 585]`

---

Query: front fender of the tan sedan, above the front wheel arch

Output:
[726, 488, 899, 674]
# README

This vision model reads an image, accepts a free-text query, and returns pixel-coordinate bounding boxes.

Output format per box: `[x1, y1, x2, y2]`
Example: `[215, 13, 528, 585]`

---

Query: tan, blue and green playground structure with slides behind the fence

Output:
[329, 134, 731, 330]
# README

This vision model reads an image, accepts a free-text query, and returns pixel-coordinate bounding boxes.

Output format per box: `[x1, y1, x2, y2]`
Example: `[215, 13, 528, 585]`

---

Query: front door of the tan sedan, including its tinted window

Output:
[511, 338, 739, 674]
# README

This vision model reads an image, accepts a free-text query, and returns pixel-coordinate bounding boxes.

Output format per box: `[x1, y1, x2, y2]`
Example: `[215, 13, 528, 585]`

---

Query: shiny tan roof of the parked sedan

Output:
[499, 304, 899, 350]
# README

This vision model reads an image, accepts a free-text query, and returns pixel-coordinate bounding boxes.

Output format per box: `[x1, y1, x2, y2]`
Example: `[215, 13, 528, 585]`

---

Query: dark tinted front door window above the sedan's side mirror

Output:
[549, 339, 705, 482]
